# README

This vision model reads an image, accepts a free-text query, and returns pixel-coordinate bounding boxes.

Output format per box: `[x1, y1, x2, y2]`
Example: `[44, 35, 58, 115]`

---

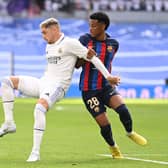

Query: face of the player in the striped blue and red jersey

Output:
[89, 19, 105, 38]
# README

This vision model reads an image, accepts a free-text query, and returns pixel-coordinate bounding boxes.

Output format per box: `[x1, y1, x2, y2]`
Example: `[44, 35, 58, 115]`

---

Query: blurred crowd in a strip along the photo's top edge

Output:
[0, 0, 168, 16]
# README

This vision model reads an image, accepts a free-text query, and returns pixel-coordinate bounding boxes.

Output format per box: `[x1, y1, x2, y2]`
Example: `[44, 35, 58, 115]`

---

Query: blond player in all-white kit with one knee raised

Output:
[0, 18, 120, 162]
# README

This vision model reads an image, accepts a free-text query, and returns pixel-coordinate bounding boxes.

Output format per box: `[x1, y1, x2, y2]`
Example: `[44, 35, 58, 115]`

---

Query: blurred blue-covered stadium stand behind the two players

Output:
[0, 0, 168, 98]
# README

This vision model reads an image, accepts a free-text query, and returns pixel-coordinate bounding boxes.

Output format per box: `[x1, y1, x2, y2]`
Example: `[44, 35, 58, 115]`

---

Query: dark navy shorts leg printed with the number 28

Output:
[82, 91, 106, 118]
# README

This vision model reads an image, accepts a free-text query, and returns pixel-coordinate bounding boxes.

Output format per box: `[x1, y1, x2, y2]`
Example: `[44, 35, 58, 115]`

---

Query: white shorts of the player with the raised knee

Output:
[18, 76, 65, 106]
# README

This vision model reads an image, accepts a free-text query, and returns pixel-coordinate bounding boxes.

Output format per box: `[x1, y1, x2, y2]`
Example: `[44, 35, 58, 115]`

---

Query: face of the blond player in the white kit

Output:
[41, 26, 57, 44]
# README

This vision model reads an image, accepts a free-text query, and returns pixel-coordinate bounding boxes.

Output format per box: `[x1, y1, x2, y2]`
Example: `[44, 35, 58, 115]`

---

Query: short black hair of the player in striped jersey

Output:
[90, 12, 110, 30]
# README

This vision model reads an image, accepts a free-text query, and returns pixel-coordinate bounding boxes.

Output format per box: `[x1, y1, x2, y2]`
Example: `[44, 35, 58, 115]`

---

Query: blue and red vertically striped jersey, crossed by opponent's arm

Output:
[79, 34, 119, 91]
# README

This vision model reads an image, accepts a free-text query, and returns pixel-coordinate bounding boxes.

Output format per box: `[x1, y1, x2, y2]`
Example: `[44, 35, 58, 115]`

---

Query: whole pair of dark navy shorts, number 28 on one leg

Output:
[82, 85, 119, 117]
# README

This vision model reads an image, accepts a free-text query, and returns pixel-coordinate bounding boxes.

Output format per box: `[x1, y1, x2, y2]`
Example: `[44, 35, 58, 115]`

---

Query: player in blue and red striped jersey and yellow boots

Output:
[76, 12, 147, 159]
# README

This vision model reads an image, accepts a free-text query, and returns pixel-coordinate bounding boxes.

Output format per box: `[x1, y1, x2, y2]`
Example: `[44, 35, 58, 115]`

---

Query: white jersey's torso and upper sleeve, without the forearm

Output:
[44, 34, 88, 91]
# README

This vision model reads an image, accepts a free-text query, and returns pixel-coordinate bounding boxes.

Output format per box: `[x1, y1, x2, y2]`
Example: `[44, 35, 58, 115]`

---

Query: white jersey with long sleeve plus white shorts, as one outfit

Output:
[18, 34, 109, 106]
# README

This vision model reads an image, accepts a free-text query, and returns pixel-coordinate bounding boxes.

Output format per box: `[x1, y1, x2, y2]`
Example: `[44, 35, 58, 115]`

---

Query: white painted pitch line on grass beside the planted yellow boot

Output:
[99, 154, 168, 165]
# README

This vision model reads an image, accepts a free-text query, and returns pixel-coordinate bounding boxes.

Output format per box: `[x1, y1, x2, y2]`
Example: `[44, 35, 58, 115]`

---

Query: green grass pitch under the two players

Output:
[0, 98, 168, 168]
